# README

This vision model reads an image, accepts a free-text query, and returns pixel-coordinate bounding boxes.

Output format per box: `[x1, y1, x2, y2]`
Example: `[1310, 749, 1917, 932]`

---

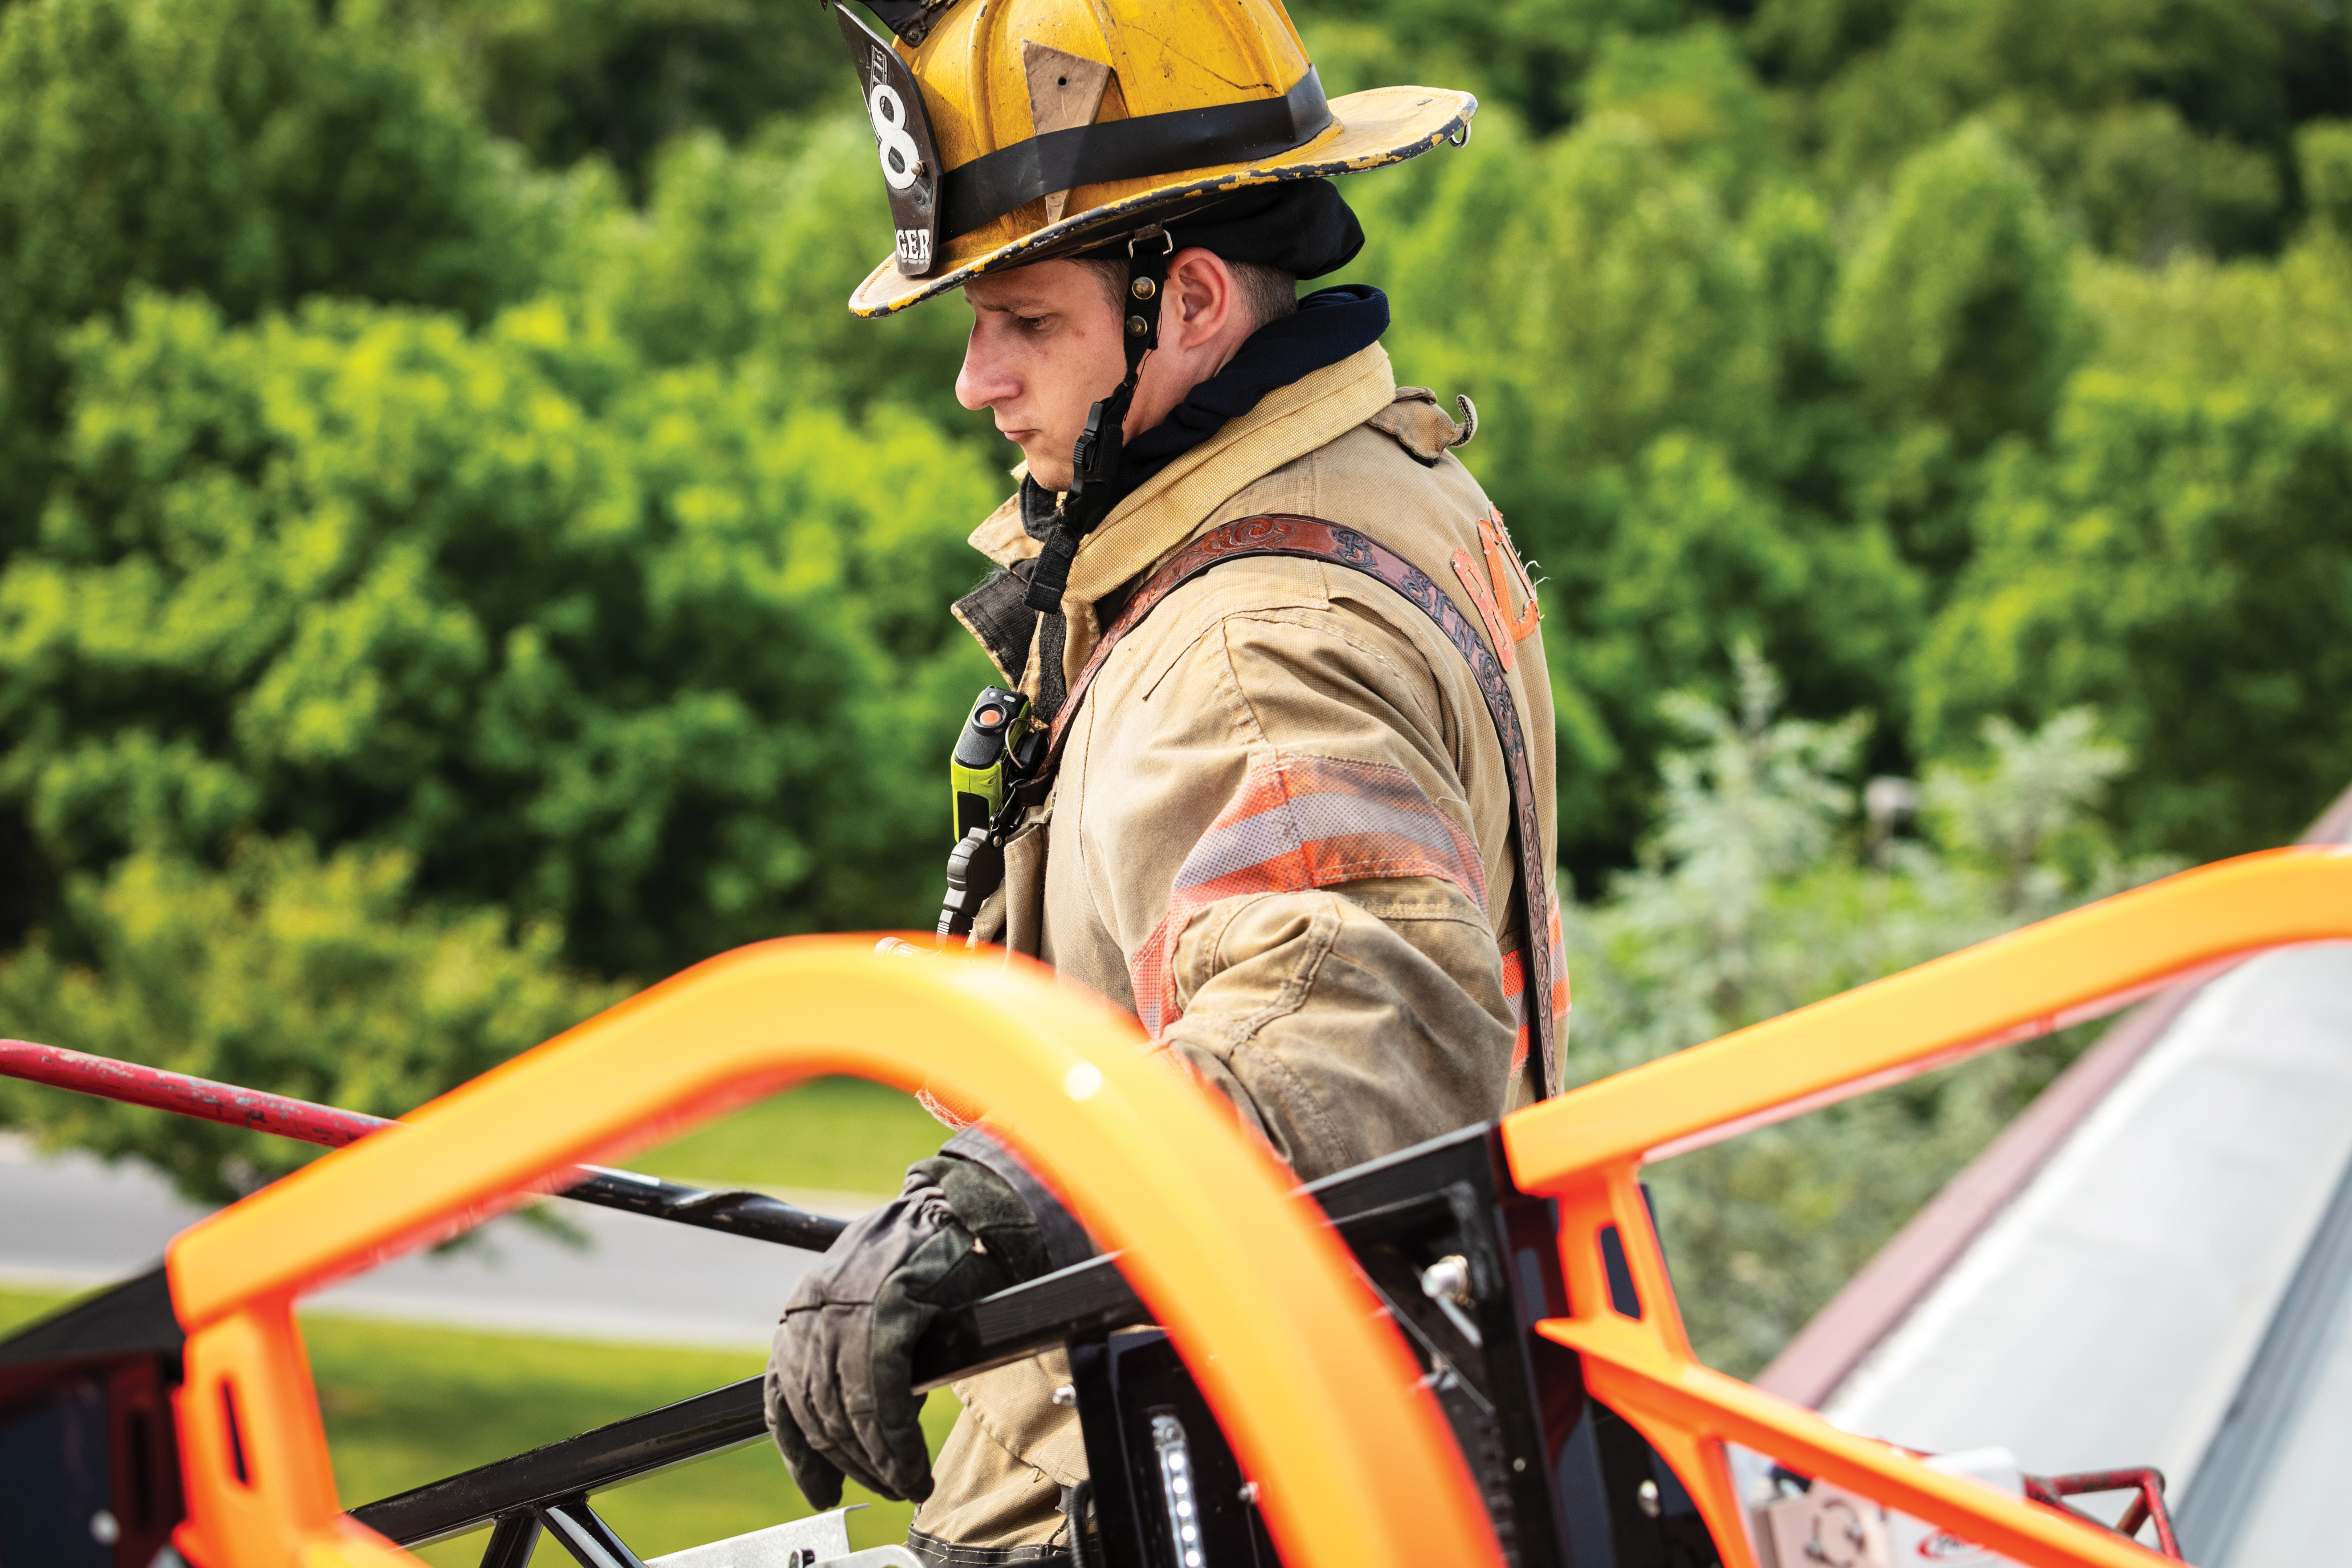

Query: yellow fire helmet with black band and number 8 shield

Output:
[833, 0, 1477, 317]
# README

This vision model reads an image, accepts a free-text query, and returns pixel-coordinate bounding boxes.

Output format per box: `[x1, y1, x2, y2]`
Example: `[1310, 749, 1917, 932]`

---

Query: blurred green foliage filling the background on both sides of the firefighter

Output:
[0, 0, 2352, 1298]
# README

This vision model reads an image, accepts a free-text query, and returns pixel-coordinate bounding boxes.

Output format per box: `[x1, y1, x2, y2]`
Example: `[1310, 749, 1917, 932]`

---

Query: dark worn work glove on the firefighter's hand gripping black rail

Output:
[764, 1128, 1094, 1509]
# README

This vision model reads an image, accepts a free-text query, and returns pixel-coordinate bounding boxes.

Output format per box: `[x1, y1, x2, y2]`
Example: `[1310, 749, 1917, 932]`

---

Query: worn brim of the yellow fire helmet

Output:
[849, 87, 1477, 317]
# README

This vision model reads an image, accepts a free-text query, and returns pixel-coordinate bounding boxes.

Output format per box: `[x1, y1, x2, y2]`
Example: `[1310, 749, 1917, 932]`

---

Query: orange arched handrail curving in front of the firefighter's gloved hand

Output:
[167, 938, 1500, 1568]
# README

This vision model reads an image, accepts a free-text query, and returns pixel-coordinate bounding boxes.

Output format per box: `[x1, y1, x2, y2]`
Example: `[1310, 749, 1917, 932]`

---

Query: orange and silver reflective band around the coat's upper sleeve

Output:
[1129, 755, 1486, 1039]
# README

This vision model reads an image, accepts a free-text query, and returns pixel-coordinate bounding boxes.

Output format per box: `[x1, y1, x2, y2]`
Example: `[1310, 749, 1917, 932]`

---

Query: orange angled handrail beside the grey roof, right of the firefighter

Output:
[1503, 849, 2352, 1568]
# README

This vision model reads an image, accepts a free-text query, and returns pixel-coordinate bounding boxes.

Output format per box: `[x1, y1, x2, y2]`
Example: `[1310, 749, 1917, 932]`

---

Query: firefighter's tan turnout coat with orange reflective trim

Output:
[915, 343, 1567, 1566]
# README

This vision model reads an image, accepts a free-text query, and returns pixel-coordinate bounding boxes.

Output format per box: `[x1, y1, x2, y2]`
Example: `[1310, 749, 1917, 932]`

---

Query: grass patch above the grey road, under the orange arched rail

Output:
[623, 1079, 948, 1194]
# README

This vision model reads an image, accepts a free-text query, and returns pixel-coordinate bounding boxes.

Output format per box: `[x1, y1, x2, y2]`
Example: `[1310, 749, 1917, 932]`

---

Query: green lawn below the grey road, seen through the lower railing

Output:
[0, 1298, 955, 1568]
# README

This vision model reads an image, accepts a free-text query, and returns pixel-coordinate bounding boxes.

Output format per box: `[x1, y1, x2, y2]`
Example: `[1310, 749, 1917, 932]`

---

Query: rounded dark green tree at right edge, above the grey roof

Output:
[1915, 371, 2352, 858]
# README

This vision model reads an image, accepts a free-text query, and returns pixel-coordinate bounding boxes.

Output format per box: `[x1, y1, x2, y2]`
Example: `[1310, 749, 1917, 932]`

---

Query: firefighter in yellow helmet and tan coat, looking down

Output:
[767, 0, 1567, 1566]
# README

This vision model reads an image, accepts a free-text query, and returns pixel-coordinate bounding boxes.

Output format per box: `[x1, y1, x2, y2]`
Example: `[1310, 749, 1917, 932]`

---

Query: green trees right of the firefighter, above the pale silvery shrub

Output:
[1303, 0, 2352, 886]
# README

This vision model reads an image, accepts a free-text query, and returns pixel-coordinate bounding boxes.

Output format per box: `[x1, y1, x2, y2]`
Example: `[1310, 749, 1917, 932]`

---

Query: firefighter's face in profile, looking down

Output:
[955, 261, 1127, 489]
